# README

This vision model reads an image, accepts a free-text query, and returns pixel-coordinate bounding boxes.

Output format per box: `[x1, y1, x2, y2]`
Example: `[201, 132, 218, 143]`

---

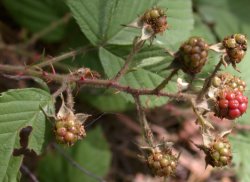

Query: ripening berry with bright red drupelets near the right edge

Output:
[215, 89, 248, 119]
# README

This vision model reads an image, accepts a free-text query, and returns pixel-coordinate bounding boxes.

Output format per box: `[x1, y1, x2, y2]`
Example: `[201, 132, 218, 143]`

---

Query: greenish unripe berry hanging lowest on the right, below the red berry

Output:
[205, 137, 232, 167]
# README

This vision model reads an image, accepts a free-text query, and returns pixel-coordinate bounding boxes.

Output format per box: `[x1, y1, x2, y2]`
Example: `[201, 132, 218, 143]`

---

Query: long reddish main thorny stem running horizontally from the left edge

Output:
[0, 64, 196, 100]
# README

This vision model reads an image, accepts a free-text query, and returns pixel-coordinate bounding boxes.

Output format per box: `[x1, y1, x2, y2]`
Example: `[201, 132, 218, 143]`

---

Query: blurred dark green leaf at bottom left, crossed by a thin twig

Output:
[38, 127, 111, 182]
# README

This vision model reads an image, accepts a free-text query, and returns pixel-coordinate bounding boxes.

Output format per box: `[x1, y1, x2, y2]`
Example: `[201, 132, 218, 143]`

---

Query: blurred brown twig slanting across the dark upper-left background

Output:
[22, 13, 72, 47]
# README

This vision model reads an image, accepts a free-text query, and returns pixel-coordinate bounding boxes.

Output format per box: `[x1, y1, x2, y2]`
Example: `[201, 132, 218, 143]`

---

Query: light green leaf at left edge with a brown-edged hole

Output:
[0, 89, 54, 182]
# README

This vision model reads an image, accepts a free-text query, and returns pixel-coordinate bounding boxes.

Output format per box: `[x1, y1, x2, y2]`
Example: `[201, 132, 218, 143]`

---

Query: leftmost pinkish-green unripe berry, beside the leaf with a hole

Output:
[55, 120, 86, 145]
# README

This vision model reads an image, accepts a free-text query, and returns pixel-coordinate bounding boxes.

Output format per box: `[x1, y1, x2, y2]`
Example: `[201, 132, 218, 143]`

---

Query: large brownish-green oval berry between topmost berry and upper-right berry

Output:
[177, 37, 209, 75]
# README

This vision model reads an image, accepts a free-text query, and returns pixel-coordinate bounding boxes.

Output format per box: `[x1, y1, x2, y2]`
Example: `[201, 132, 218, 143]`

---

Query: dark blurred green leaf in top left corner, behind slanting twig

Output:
[3, 0, 68, 42]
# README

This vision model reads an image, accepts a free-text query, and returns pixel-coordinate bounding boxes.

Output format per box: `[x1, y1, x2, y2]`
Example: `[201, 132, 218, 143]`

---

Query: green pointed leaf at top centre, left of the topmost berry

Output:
[67, 0, 154, 45]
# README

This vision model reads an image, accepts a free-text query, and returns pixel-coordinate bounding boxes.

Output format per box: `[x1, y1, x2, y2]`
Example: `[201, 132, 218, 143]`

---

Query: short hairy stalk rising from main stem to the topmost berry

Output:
[113, 37, 145, 82]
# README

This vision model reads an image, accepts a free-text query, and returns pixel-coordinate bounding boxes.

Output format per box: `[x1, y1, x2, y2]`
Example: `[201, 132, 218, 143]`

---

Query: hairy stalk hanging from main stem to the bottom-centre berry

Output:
[133, 94, 154, 147]
